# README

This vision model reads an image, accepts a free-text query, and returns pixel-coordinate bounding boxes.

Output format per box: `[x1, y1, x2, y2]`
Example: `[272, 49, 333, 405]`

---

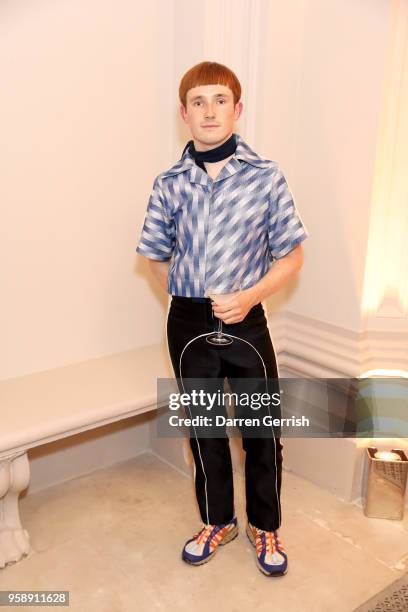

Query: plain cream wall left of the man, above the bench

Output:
[0, 0, 168, 378]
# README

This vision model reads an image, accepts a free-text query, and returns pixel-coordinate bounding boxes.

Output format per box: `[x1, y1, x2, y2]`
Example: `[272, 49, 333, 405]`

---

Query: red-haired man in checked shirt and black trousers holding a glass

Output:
[136, 62, 307, 576]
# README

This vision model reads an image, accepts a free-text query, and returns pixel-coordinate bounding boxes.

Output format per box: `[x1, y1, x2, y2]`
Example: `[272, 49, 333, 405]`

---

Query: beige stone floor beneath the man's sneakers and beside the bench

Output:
[0, 454, 408, 612]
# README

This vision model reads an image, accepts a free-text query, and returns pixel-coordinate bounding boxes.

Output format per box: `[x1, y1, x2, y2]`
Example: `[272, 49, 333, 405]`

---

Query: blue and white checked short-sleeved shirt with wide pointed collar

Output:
[136, 134, 309, 297]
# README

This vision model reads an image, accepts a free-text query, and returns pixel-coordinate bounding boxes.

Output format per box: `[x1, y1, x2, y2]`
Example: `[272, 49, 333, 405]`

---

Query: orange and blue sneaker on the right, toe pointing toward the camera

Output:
[246, 522, 288, 576]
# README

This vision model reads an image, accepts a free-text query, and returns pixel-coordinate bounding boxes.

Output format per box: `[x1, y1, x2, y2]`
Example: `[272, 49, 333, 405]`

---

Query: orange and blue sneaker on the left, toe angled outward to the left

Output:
[181, 517, 238, 565]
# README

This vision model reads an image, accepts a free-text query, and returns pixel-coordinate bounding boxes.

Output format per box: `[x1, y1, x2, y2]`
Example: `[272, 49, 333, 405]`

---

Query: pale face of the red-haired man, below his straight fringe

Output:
[180, 85, 242, 151]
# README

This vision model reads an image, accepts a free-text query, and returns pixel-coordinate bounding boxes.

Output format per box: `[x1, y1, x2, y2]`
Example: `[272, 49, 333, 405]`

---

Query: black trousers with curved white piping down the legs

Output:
[167, 296, 282, 531]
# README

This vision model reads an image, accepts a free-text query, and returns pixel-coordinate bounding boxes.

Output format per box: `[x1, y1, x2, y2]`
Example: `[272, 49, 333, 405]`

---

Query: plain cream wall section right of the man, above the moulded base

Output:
[261, 0, 389, 330]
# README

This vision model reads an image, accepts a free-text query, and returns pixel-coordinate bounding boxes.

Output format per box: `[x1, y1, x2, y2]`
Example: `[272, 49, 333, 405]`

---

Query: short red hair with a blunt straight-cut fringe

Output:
[179, 62, 241, 108]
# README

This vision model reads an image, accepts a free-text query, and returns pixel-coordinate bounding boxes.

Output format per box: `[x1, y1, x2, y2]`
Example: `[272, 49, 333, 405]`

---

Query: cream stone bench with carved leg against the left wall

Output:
[0, 345, 174, 568]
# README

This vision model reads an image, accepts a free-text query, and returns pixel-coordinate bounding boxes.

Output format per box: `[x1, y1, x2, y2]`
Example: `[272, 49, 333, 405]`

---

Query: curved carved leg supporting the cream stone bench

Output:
[0, 452, 30, 568]
